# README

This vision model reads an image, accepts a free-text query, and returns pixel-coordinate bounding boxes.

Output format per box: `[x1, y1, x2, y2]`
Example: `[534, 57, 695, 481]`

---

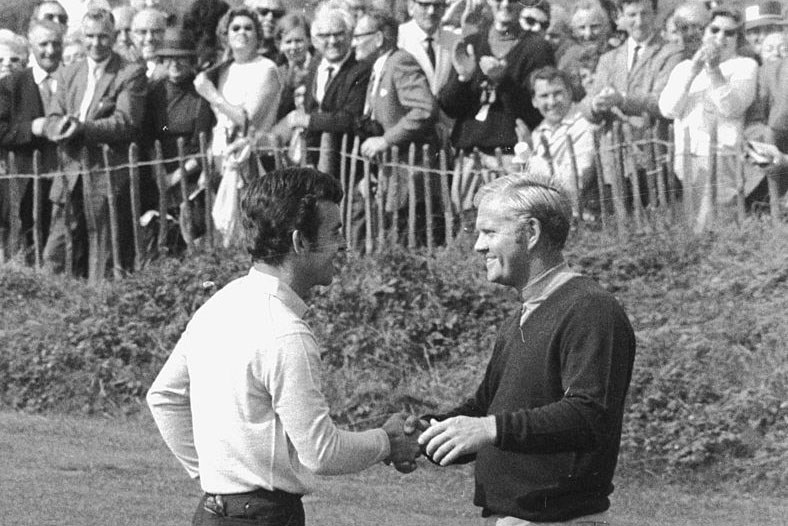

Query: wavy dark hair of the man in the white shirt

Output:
[241, 168, 343, 265]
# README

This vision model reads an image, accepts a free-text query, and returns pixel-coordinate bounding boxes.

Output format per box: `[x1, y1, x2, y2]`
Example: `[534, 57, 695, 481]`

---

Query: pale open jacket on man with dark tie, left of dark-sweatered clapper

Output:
[397, 20, 462, 96]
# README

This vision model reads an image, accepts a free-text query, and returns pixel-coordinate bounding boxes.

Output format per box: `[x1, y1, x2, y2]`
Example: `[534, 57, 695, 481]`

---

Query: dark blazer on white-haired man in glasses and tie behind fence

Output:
[305, 54, 372, 146]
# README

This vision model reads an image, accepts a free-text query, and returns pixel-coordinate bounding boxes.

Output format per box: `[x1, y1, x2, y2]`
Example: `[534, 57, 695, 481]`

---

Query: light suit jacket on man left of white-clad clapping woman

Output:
[580, 34, 683, 179]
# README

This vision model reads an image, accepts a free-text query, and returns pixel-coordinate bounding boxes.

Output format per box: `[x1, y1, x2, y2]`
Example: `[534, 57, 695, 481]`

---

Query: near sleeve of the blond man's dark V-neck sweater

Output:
[495, 297, 635, 454]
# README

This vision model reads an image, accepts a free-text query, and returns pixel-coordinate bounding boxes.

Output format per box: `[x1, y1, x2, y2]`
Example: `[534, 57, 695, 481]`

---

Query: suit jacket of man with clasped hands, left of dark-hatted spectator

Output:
[48, 52, 147, 202]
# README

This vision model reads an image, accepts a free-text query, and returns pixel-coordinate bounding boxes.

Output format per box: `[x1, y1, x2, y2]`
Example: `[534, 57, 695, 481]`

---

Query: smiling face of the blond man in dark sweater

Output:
[473, 194, 531, 289]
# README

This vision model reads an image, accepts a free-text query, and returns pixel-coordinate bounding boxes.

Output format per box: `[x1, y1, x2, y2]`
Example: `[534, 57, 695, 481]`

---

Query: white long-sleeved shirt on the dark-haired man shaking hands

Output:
[147, 268, 390, 495]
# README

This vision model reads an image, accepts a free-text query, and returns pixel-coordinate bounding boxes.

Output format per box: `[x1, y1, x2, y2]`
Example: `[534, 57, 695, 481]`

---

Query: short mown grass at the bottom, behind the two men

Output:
[0, 412, 788, 526]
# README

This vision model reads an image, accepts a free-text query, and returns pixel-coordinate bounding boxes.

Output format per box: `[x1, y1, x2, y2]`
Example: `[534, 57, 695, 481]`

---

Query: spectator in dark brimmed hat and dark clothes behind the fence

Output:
[143, 28, 215, 252]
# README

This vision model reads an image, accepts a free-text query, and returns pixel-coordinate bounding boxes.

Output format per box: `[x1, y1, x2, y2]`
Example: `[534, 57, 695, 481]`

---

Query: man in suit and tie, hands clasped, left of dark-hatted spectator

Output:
[44, 9, 146, 279]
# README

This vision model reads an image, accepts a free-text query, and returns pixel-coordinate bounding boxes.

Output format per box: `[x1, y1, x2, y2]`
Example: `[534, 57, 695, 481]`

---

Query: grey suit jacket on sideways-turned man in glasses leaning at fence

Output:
[368, 49, 438, 146]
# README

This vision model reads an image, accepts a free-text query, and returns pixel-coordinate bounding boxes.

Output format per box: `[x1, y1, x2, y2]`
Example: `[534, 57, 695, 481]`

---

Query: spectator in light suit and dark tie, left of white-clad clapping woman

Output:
[581, 0, 681, 210]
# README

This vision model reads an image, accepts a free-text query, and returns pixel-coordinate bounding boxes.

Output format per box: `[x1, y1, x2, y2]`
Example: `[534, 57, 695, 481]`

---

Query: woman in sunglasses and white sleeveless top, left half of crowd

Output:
[194, 7, 281, 165]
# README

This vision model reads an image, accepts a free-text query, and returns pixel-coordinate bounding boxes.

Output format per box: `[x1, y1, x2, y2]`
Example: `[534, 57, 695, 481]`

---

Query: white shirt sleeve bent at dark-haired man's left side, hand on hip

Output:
[147, 328, 200, 479]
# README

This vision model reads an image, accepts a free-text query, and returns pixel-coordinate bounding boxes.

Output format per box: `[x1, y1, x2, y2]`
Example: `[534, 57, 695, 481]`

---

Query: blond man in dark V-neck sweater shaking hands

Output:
[416, 171, 635, 526]
